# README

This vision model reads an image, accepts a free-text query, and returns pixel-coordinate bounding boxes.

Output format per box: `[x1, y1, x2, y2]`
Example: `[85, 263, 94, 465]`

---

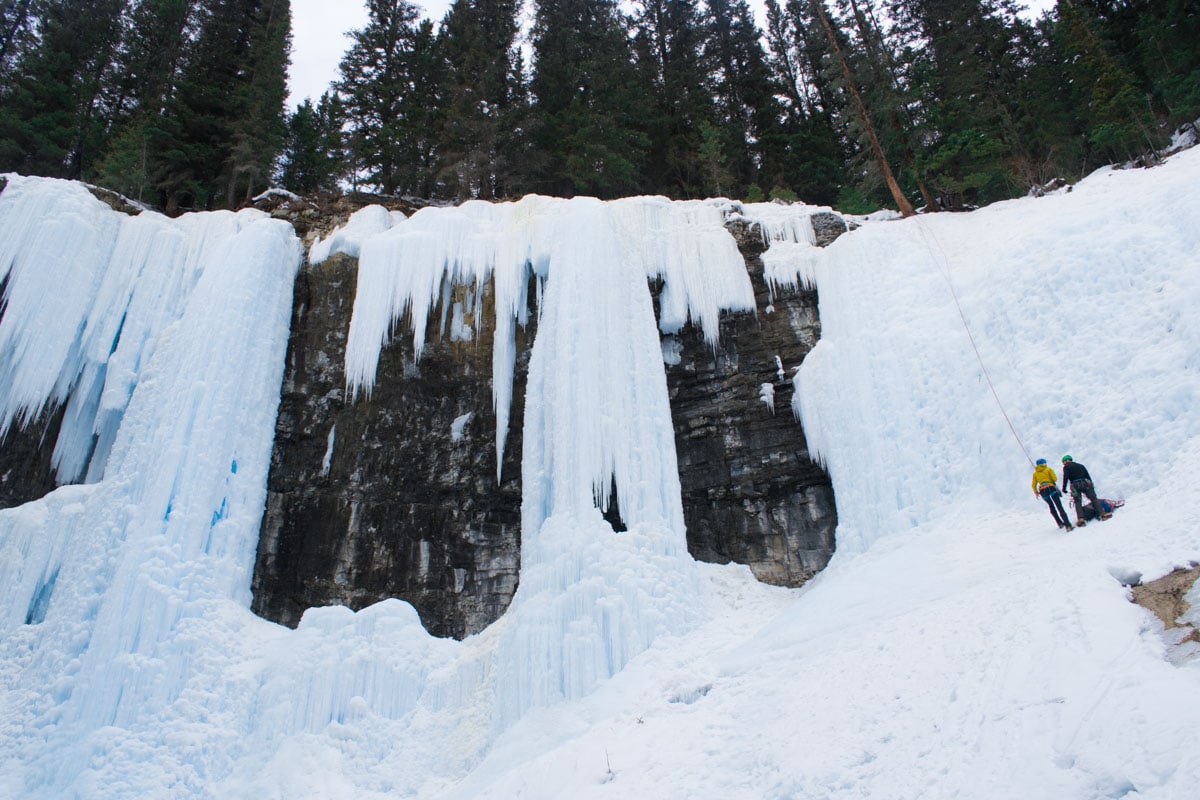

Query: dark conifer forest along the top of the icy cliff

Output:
[0, 0, 1200, 213]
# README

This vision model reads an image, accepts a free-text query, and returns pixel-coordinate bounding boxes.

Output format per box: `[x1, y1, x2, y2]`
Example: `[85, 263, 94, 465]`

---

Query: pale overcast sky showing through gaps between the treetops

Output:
[289, 0, 1055, 106]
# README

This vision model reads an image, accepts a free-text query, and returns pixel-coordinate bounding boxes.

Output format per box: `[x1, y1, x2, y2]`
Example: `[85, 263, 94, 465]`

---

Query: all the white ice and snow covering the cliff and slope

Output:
[0, 149, 1200, 800]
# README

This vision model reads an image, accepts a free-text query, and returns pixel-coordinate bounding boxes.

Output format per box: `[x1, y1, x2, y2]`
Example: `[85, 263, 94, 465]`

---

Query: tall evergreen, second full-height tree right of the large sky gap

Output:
[438, 0, 520, 199]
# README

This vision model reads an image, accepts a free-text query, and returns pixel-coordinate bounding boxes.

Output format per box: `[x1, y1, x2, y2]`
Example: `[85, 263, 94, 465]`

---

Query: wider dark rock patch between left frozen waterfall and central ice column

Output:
[253, 255, 532, 637]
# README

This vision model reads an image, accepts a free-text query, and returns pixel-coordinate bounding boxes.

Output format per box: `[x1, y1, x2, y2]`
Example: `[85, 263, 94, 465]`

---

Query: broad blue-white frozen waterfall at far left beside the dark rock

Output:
[0, 175, 300, 796]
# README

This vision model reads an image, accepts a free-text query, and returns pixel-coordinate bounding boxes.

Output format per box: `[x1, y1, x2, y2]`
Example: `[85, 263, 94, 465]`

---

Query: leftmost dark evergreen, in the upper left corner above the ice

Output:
[0, 0, 125, 178]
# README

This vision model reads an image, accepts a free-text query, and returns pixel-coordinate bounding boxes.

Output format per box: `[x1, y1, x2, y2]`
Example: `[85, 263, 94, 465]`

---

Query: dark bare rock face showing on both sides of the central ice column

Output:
[253, 206, 846, 637]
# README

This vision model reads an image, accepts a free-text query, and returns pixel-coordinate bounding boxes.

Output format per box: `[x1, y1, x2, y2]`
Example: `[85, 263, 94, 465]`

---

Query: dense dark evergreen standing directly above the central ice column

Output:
[530, 0, 650, 197]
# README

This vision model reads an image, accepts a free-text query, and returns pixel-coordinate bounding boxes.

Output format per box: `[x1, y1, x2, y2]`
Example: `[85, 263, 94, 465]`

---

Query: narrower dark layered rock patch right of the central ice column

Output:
[667, 215, 846, 587]
